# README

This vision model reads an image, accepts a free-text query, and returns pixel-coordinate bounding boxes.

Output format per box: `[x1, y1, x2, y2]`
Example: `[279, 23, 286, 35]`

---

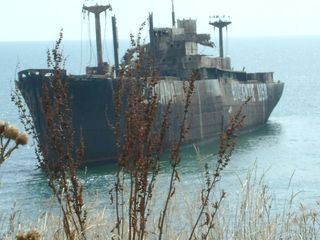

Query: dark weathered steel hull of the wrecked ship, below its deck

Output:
[18, 70, 284, 165]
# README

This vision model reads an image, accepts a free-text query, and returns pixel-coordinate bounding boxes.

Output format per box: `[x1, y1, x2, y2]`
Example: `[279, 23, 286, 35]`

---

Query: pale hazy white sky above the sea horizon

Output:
[0, 0, 320, 41]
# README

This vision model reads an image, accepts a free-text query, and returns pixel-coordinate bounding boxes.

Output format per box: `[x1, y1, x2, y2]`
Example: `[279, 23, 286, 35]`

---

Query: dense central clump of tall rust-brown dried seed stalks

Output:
[112, 24, 195, 240]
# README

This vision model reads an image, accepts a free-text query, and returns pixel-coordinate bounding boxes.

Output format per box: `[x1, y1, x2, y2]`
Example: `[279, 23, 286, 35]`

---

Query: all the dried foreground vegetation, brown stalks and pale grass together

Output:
[1, 31, 319, 240]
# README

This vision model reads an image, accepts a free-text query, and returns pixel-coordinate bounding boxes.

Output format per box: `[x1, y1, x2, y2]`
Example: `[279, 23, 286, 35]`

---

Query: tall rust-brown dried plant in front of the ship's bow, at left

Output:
[12, 31, 87, 240]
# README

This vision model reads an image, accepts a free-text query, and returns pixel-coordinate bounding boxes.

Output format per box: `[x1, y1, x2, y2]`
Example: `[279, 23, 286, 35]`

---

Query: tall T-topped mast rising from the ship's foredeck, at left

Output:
[83, 4, 111, 74]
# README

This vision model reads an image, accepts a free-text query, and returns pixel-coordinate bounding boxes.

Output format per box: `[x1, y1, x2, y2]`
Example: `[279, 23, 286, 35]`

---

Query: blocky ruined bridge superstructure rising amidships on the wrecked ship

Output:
[149, 15, 231, 78]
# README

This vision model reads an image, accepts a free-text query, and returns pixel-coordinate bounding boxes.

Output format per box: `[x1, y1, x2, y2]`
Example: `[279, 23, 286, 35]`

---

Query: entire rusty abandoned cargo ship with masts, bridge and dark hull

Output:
[17, 5, 284, 164]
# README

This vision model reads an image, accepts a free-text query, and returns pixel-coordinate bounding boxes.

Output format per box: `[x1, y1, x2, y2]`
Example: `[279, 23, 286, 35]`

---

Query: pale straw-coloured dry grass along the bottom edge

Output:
[1, 165, 320, 240]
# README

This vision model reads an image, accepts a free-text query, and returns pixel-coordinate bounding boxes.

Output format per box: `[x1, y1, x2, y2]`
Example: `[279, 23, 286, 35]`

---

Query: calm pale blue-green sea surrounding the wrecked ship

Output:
[0, 36, 320, 221]
